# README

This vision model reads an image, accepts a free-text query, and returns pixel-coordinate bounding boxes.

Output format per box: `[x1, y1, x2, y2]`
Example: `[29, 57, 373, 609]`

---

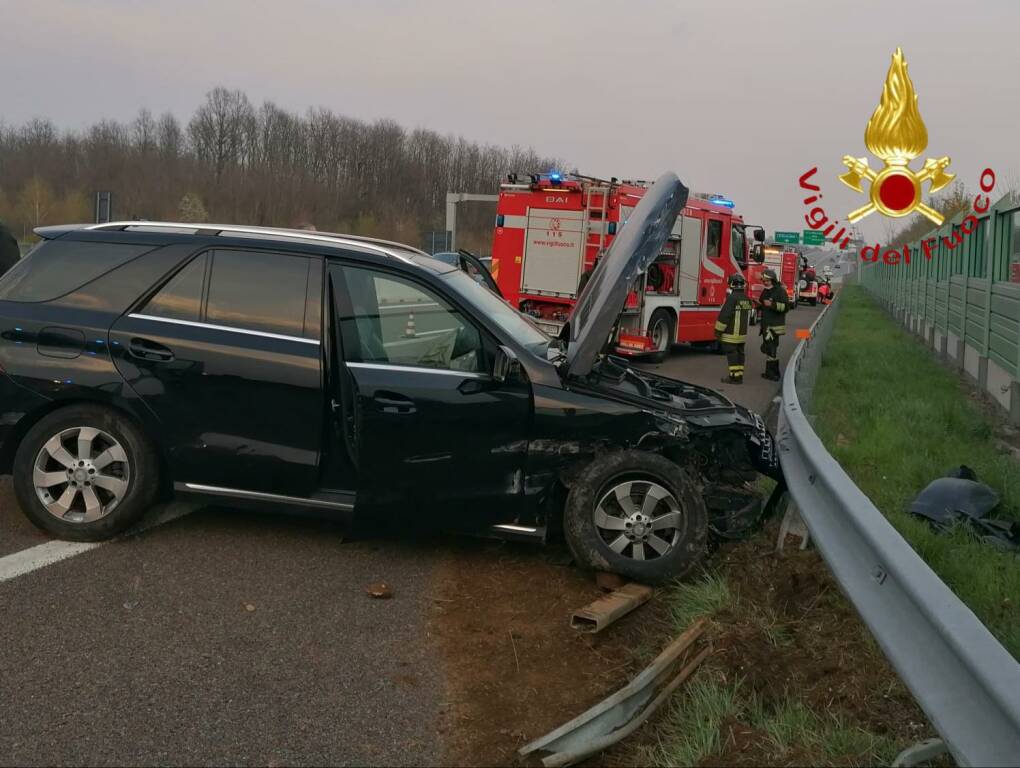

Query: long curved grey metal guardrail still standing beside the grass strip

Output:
[778, 289, 1020, 766]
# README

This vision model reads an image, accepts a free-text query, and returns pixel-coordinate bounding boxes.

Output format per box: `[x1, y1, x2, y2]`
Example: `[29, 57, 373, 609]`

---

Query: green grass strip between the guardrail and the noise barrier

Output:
[813, 286, 1020, 659]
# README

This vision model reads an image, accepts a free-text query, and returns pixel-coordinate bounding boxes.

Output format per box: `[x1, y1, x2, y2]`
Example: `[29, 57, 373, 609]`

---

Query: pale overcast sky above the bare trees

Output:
[0, 0, 1020, 238]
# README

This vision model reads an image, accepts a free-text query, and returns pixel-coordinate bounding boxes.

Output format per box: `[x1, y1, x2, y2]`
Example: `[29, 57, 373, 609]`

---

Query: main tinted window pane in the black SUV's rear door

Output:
[205, 251, 310, 336]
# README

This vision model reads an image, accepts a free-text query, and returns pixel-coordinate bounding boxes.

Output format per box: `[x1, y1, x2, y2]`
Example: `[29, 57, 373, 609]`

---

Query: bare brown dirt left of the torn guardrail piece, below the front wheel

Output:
[430, 544, 670, 766]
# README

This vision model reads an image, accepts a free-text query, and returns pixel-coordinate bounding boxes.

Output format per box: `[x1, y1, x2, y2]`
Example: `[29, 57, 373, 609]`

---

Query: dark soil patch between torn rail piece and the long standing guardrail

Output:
[712, 524, 935, 765]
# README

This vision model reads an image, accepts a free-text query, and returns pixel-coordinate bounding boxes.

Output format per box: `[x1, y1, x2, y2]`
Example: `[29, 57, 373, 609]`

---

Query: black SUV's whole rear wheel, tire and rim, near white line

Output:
[12, 405, 159, 542]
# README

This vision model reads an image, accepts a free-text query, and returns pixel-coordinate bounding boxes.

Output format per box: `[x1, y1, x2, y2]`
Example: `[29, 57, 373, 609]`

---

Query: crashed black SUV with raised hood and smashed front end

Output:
[0, 174, 777, 581]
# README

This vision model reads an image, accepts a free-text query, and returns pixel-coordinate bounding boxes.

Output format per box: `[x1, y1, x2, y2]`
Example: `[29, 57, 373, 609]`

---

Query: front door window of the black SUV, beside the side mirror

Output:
[340, 267, 483, 372]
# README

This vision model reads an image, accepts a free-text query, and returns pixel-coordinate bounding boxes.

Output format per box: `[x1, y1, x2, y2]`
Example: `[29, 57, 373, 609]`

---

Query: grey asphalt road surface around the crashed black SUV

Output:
[0, 307, 817, 765]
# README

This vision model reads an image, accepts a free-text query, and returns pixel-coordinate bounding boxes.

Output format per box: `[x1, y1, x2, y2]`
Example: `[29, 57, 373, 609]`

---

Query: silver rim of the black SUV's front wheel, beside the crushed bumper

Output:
[595, 479, 684, 560]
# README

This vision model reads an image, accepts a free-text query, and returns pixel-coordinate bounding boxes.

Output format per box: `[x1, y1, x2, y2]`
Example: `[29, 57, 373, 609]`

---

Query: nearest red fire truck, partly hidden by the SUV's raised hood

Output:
[492, 173, 764, 358]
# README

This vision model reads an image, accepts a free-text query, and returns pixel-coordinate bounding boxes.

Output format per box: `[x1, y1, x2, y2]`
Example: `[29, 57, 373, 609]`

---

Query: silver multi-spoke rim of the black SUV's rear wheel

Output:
[32, 426, 131, 523]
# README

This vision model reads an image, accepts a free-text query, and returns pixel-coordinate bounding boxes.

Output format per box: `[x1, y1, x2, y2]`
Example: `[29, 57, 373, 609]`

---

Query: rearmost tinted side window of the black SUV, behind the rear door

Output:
[0, 240, 153, 302]
